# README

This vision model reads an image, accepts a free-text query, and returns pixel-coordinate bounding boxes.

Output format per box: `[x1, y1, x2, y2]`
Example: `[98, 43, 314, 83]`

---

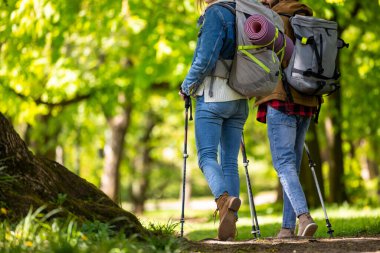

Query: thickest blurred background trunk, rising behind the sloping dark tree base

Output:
[100, 105, 132, 202]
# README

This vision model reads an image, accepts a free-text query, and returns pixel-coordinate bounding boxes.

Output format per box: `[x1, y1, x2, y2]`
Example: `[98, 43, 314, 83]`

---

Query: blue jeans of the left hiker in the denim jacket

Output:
[195, 96, 248, 199]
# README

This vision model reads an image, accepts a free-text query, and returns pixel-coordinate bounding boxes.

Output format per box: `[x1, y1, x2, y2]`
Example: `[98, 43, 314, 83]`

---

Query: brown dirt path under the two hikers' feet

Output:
[183, 237, 380, 253]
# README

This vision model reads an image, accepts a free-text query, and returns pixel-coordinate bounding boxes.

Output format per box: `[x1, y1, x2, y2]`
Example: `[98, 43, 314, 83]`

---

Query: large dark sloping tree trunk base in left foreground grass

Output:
[0, 113, 146, 235]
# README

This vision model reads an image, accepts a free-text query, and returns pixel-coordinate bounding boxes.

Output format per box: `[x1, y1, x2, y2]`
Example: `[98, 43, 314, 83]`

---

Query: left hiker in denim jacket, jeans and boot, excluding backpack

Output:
[181, 0, 248, 240]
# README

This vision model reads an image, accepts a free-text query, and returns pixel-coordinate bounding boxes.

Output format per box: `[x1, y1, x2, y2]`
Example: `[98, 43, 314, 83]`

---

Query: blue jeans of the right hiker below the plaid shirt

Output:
[267, 106, 310, 229]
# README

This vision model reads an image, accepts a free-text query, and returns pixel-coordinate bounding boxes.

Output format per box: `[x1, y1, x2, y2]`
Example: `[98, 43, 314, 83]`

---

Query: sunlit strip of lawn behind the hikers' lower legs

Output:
[140, 201, 380, 241]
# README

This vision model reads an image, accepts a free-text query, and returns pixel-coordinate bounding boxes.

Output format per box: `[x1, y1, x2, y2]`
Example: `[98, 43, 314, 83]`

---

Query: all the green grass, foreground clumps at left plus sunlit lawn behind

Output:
[0, 204, 380, 253]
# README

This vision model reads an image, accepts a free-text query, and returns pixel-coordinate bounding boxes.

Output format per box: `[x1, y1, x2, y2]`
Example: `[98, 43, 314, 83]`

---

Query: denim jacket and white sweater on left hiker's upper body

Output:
[181, 1, 244, 102]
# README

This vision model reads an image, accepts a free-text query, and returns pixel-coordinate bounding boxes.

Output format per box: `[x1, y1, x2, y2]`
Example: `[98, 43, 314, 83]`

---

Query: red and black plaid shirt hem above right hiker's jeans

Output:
[256, 100, 317, 123]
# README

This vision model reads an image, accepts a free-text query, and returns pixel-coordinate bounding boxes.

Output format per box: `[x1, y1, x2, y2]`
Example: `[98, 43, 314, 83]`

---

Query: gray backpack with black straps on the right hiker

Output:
[284, 15, 348, 95]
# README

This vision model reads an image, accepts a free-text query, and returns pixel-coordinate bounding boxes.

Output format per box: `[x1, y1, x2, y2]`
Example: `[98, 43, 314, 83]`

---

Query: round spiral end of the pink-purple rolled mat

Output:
[244, 14, 276, 45]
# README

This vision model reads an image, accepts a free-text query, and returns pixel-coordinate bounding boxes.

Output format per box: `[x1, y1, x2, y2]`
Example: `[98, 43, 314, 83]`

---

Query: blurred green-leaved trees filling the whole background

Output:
[0, 0, 380, 212]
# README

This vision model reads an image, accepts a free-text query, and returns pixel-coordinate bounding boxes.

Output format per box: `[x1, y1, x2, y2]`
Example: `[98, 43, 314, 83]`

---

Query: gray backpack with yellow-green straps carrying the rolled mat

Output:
[212, 0, 284, 98]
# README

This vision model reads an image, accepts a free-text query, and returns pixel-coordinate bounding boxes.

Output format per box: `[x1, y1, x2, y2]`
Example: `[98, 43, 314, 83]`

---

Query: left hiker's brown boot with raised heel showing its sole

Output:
[216, 193, 241, 241]
